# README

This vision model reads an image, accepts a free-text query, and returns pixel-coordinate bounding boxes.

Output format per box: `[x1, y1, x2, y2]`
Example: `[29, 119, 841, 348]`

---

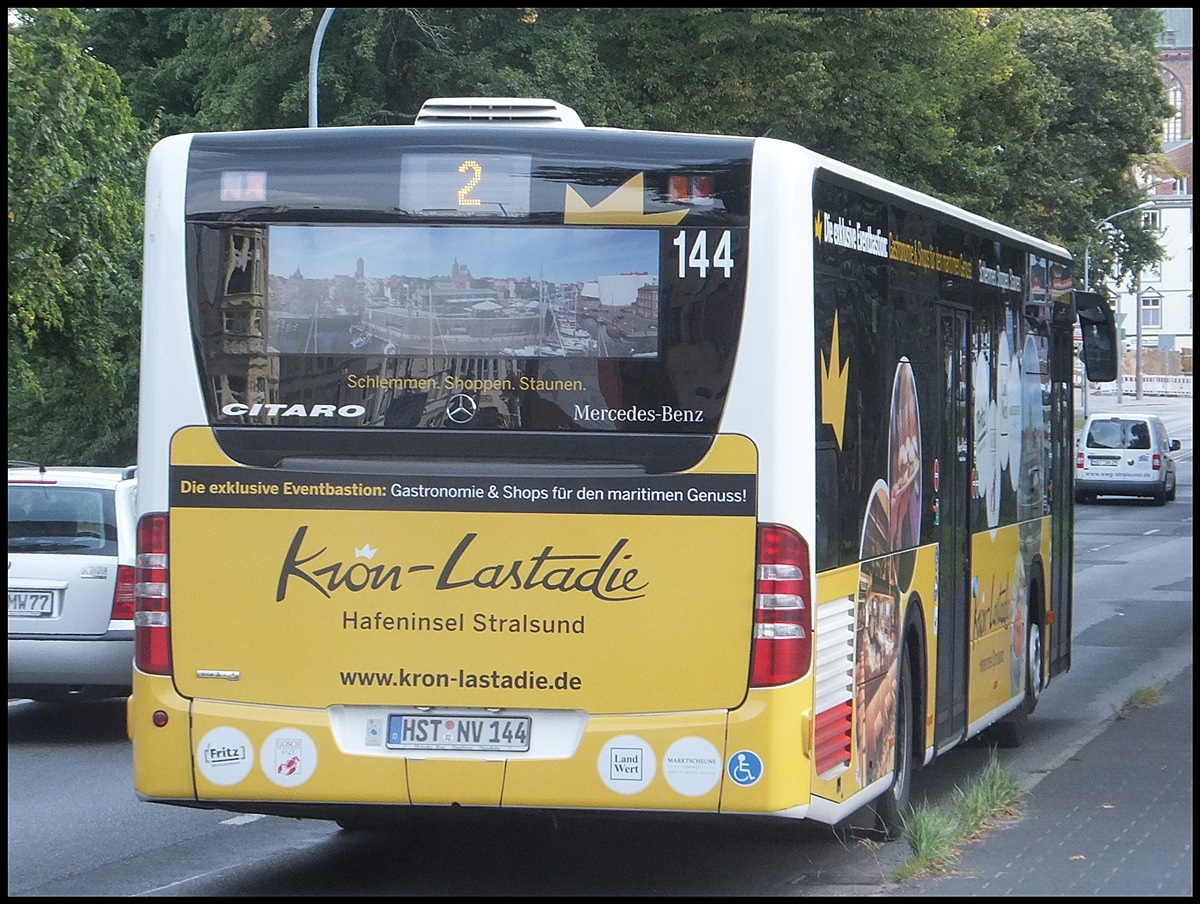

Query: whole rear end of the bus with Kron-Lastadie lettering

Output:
[128, 126, 812, 820]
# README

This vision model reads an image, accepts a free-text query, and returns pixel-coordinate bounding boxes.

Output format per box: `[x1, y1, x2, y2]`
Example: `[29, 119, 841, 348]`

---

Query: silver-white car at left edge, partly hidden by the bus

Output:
[8, 461, 137, 701]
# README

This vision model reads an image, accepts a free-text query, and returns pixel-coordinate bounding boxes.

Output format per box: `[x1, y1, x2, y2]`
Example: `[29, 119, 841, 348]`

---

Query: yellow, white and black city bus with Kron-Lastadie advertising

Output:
[128, 98, 1116, 836]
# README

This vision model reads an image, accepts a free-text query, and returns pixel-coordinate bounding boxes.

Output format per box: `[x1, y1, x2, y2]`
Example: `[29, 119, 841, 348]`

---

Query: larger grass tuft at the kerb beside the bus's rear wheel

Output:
[893, 750, 1021, 882]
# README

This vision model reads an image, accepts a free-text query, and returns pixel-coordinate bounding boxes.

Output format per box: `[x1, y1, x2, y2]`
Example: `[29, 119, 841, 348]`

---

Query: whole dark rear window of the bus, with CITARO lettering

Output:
[188, 222, 746, 435]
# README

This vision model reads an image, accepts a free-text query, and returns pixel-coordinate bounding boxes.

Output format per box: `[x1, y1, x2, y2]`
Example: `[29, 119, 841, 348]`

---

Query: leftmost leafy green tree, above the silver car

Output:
[8, 8, 148, 465]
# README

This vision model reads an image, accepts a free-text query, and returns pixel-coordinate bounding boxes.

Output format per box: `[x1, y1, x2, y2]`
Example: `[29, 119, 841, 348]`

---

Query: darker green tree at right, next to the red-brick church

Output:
[991, 7, 1171, 282]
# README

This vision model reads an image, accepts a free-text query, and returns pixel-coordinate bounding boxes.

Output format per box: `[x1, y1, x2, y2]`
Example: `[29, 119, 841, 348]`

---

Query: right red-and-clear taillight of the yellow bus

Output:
[750, 525, 812, 688]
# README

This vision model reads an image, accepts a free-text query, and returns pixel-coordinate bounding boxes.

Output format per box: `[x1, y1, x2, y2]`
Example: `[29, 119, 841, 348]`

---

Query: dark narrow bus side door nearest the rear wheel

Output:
[934, 307, 971, 748]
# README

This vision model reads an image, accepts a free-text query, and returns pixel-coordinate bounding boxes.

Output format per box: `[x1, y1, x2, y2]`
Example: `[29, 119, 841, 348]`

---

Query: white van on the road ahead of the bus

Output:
[1075, 412, 1180, 505]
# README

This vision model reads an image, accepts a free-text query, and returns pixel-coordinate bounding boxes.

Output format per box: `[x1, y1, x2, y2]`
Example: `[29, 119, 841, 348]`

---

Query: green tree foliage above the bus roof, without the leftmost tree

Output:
[70, 7, 1169, 270]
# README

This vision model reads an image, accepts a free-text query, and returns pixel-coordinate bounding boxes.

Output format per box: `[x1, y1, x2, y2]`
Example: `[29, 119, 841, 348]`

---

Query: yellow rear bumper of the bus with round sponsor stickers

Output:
[128, 675, 825, 820]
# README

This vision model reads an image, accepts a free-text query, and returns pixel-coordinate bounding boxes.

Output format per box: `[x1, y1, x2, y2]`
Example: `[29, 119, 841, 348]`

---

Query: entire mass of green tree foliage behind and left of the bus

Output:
[8, 7, 1169, 465]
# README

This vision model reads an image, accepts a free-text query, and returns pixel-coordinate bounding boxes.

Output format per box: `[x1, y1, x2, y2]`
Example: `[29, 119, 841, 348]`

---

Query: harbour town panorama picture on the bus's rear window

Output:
[266, 226, 659, 358]
